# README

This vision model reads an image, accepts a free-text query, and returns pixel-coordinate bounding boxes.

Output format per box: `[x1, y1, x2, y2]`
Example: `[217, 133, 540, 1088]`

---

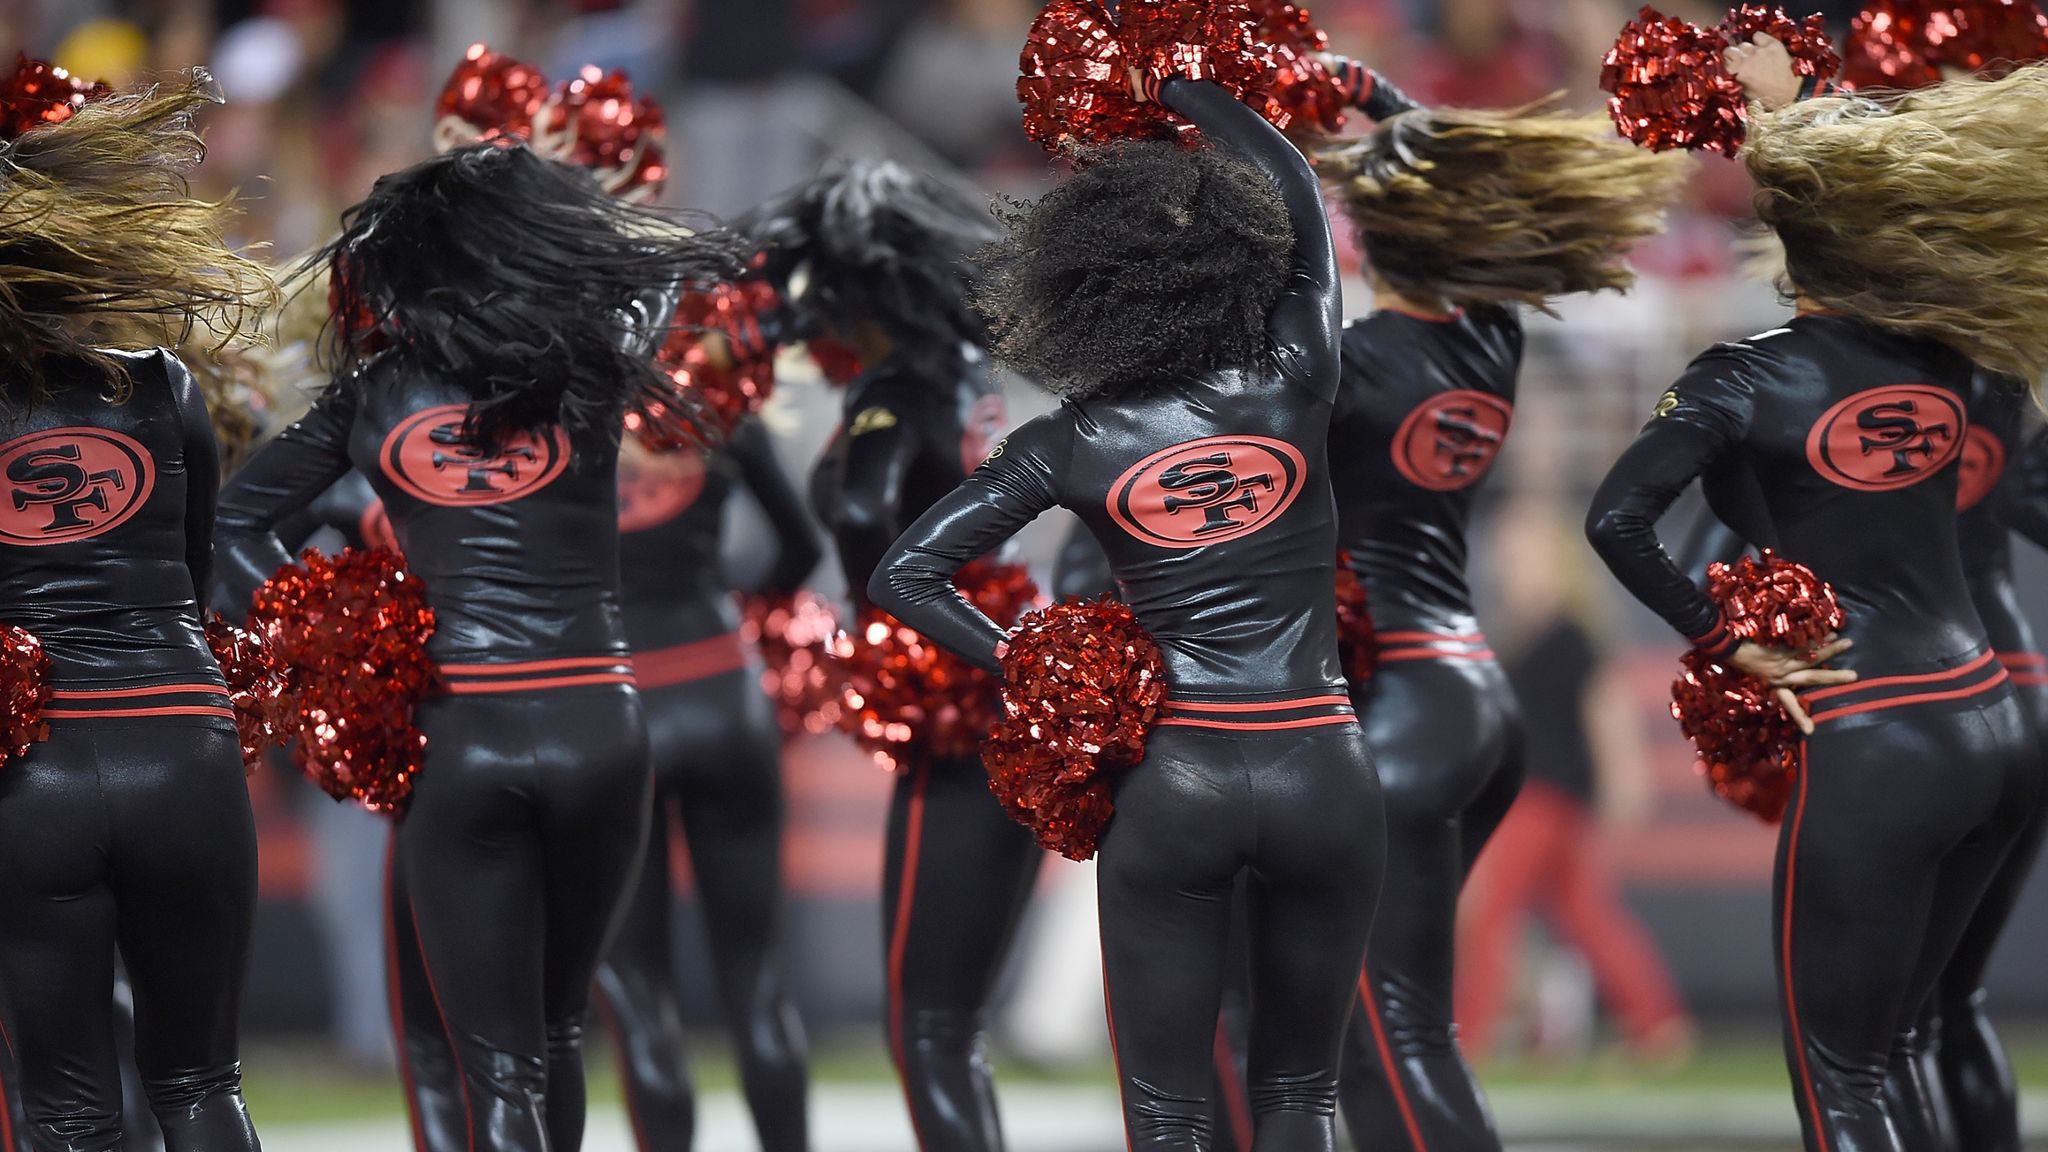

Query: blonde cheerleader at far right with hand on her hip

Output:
[1587, 59, 2048, 1152]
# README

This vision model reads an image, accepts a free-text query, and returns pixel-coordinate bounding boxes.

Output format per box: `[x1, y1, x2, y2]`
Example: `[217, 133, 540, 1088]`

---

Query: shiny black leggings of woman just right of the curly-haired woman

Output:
[1337, 658, 1522, 1152]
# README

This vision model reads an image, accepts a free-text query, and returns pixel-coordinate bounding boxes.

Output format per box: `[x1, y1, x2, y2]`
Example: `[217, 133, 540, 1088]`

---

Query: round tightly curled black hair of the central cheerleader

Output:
[975, 141, 1294, 400]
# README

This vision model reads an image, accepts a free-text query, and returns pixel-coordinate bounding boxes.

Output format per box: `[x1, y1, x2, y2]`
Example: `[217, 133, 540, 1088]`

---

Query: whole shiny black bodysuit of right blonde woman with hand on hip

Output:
[1587, 314, 2038, 1152]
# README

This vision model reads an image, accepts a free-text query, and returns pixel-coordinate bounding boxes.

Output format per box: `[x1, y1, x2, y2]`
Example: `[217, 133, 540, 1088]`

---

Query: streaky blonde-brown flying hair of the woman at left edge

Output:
[0, 68, 276, 404]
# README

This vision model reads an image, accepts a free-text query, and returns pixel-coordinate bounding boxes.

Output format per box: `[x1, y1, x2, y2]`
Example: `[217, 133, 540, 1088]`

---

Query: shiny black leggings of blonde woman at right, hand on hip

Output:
[1772, 691, 2040, 1152]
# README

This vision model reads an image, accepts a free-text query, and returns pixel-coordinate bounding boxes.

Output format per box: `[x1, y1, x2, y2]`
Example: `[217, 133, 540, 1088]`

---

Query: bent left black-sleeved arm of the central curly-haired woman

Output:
[868, 412, 1071, 672]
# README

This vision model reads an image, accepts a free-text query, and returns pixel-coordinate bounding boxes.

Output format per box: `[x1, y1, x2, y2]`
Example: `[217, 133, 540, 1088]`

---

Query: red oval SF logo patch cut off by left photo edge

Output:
[0, 428, 156, 547]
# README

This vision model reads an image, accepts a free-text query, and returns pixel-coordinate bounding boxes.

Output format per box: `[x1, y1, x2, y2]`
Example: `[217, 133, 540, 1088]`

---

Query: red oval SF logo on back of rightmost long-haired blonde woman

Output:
[1806, 383, 1968, 492]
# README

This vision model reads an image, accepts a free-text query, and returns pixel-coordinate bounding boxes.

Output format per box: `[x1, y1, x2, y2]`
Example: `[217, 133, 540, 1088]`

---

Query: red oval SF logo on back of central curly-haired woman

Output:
[1108, 437, 1309, 547]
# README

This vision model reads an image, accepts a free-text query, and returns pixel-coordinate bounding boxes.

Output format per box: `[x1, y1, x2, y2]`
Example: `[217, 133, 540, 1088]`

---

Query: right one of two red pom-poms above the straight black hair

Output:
[532, 64, 668, 201]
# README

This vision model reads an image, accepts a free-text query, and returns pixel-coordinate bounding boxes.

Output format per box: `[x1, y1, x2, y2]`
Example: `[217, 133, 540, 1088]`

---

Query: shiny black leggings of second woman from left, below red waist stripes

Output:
[393, 687, 651, 1152]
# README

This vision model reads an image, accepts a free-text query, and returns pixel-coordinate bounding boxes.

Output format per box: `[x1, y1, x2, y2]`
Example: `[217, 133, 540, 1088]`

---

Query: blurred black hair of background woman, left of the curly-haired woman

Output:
[733, 162, 997, 381]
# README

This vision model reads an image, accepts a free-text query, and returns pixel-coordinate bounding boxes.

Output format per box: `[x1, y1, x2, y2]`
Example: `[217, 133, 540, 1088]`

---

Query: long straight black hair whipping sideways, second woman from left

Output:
[311, 139, 745, 445]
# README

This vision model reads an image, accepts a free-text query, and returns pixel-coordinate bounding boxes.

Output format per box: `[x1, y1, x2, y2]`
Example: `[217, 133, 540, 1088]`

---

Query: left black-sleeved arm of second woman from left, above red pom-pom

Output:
[213, 387, 356, 615]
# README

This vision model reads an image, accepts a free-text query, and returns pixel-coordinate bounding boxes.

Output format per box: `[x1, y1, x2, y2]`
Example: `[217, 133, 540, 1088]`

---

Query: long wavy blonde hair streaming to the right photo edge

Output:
[1743, 66, 2048, 379]
